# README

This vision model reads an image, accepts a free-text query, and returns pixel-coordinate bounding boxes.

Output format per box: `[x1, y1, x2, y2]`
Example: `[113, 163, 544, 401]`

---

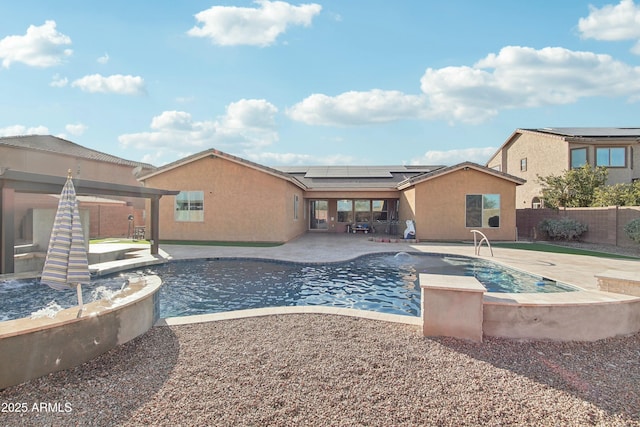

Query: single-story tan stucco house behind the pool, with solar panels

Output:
[139, 149, 524, 242]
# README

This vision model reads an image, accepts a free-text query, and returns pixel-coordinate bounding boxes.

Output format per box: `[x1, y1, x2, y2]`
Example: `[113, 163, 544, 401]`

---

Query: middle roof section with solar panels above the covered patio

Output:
[278, 165, 444, 191]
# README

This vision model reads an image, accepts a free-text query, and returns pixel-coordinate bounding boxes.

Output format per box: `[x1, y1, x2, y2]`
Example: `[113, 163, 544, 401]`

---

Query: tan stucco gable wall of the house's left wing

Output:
[146, 157, 306, 242]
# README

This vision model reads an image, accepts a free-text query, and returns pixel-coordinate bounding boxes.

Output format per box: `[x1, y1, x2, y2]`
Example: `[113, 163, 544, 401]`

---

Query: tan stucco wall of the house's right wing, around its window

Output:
[400, 169, 516, 241]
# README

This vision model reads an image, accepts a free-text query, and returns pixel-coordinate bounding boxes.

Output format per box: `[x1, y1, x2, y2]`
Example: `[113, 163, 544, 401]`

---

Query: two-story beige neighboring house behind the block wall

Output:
[486, 127, 640, 209]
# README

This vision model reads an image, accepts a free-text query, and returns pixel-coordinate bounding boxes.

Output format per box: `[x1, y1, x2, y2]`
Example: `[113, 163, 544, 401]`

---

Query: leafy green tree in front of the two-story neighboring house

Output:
[538, 164, 608, 209]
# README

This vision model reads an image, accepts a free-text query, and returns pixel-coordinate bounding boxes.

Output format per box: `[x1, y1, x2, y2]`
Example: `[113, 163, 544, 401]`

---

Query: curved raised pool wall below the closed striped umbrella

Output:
[0, 276, 161, 389]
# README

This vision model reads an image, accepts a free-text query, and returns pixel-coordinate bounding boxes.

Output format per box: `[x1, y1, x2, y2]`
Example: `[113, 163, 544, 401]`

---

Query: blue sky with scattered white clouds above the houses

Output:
[0, 0, 640, 166]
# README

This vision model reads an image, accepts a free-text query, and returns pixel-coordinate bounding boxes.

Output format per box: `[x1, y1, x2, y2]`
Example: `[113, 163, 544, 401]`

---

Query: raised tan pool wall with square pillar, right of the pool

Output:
[420, 274, 640, 342]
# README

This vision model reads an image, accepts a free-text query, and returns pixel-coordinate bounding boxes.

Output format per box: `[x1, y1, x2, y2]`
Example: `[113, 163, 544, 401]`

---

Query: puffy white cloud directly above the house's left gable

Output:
[118, 99, 278, 158]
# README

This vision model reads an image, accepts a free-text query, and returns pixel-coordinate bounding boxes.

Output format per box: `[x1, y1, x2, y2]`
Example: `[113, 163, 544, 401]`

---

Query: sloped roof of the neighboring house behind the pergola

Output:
[0, 135, 156, 169]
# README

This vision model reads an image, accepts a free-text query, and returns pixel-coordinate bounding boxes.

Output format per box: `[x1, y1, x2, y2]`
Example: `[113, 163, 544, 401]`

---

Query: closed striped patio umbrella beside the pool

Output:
[40, 170, 91, 311]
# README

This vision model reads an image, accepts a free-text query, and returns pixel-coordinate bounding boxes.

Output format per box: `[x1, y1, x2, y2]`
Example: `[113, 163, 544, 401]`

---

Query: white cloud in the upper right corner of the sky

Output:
[578, 0, 640, 55]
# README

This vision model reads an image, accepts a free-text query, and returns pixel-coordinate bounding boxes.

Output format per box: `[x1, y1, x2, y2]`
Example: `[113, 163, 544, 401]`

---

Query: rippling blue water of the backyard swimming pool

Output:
[0, 253, 576, 320]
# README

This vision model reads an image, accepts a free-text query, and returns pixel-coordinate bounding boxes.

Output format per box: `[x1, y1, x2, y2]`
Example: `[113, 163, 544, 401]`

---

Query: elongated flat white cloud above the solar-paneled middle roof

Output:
[287, 89, 426, 126]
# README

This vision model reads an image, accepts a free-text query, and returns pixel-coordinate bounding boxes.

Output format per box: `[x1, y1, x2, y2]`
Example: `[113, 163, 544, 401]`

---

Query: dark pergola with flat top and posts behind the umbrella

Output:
[0, 168, 179, 274]
